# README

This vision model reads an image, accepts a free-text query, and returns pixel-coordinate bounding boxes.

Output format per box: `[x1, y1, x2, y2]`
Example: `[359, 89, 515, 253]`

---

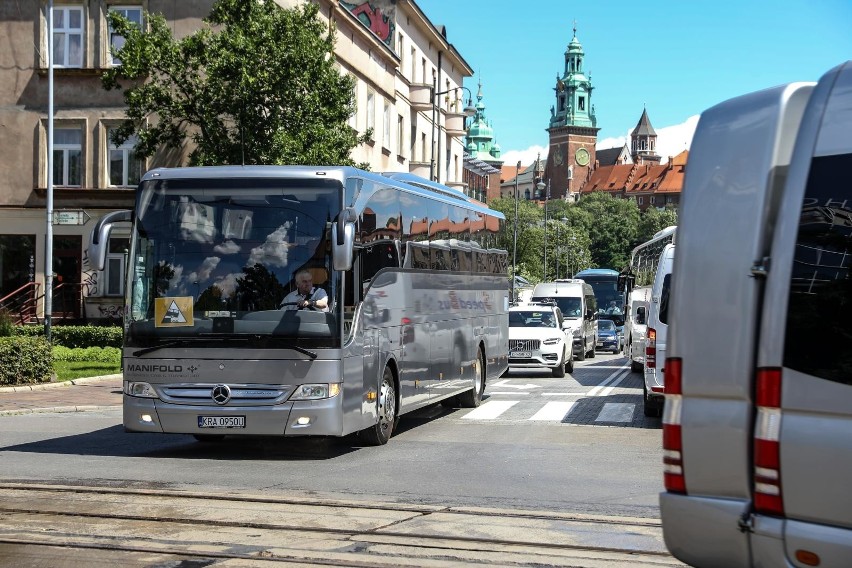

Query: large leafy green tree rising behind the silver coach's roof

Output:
[102, 0, 371, 167]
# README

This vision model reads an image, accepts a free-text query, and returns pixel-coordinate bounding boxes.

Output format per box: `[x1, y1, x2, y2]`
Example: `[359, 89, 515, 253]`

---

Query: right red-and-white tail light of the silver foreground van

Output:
[754, 368, 784, 516]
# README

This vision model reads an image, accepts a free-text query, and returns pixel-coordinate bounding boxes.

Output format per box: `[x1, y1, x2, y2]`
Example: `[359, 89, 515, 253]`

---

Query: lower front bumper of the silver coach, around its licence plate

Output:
[123, 395, 343, 436]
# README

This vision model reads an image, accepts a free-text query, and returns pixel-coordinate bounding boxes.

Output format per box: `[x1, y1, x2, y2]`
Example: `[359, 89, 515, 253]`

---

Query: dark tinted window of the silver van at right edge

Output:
[784, 154, 852, 384]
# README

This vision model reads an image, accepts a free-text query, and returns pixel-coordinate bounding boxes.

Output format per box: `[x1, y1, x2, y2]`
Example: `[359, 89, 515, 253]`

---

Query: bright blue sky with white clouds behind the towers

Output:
[415, 0, 852, 165]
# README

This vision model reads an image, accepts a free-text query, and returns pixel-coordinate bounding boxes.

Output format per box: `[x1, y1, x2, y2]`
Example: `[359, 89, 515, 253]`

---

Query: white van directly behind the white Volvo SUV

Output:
[530, 278, 598, 361]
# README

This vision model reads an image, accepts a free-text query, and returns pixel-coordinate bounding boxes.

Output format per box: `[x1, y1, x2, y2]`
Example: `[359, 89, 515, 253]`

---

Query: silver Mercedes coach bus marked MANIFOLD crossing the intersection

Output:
[89, 166, 509, 445]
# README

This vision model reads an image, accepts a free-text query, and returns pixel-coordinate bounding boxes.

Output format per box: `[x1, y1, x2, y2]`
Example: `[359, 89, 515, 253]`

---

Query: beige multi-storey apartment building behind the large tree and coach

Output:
[0, 0, 473, 322]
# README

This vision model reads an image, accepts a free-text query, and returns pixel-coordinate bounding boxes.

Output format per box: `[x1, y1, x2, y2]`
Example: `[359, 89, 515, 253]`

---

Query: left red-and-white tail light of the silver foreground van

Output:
[660, 357, 686, 493]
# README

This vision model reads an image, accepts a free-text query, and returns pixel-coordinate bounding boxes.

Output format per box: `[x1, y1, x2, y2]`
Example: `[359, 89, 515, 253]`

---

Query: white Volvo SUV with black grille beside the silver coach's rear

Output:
[509, 304, 574, 377]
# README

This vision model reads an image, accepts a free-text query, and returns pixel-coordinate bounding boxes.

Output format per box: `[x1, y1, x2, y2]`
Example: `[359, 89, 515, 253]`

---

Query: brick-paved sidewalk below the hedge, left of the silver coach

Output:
[0, 374, 122, 416]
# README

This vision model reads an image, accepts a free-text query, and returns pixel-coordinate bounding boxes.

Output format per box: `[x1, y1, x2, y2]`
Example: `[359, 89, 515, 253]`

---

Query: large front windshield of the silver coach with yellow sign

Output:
[126, 178, 342, 348]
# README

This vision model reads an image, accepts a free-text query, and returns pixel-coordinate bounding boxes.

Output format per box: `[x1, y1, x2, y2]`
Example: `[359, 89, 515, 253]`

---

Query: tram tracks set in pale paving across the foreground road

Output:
[0, 483, 680, 567]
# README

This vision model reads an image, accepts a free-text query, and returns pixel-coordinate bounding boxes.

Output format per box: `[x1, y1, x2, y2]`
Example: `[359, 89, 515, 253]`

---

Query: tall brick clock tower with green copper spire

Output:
[544, 24, 600, 199]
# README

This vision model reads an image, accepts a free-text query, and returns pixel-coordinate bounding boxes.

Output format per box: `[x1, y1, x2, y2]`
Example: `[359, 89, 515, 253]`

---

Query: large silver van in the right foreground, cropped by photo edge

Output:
[660, 61, 852, 568]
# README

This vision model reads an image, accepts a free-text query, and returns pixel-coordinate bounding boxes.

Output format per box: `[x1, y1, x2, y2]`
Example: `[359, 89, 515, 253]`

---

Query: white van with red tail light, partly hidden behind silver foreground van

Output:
[642, 244, 675, 416]
